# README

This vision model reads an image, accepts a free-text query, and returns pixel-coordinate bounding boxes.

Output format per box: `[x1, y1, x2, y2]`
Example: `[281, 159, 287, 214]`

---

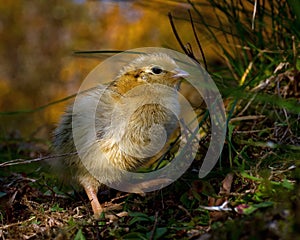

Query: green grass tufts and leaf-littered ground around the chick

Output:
[0, 0, 300, 240]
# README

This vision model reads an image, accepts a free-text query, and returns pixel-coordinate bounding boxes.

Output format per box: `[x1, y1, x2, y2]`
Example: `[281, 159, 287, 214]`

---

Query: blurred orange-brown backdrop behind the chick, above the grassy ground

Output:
[0, 0, 221, 140]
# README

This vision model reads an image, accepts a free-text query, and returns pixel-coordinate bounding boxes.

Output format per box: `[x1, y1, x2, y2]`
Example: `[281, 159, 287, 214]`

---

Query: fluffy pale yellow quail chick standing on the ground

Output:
[53, 53, 188, 217]
